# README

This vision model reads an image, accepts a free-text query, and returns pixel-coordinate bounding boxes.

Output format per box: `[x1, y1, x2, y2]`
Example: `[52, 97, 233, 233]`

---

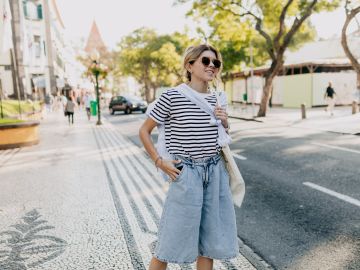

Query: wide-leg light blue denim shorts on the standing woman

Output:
[154, 154, 239, 264]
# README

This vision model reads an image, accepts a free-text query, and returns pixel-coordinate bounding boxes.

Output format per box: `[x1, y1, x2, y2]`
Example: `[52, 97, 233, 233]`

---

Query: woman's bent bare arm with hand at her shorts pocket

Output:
[139, 117, 180, 180]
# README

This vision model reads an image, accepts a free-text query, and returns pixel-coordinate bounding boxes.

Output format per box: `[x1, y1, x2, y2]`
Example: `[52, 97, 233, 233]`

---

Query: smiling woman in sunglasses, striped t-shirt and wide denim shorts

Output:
[139, 44, 239, 270]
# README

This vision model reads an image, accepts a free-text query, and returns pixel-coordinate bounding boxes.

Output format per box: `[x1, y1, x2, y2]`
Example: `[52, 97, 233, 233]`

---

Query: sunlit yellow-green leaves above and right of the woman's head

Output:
[175, 0, 341, 68]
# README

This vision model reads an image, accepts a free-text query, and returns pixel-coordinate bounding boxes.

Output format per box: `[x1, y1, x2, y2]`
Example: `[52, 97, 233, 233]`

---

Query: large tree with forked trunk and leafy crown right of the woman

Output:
[179, 0, 340, 117]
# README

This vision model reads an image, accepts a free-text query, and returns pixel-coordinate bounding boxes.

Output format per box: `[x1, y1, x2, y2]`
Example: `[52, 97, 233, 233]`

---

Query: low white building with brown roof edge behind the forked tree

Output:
[225, 32, 360, 108]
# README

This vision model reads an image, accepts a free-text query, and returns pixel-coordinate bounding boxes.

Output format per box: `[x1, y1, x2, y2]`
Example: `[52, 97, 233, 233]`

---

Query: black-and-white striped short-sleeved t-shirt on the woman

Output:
[149, 89, 221, 159]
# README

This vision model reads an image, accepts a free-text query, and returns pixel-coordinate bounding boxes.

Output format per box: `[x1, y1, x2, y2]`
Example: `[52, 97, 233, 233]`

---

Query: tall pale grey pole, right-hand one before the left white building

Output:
[44, 0, 56, 95]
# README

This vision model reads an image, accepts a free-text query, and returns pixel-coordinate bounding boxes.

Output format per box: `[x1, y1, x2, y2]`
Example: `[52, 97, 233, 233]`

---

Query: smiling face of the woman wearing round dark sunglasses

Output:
[189, 51, 220, 82]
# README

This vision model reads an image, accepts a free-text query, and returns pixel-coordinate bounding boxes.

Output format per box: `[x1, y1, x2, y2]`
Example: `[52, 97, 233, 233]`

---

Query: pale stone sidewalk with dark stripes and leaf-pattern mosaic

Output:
[0, 112, 255, 270]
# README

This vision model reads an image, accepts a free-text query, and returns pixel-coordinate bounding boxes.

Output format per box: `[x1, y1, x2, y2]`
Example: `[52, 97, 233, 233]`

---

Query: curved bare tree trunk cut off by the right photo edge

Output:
[341, 0, 360, 98]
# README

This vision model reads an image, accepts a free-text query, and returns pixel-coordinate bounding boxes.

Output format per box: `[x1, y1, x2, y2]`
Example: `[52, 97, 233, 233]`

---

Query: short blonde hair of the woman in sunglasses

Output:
[183, 44, 223, 82]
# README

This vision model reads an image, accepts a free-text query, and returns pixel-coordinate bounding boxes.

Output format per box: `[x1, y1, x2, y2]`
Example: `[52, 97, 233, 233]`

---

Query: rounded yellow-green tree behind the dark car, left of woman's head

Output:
[117, 28, 191, 102]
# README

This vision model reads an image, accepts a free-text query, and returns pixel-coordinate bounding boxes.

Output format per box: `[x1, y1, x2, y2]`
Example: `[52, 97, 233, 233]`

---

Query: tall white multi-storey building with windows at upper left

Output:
[0, 0, 81, 98]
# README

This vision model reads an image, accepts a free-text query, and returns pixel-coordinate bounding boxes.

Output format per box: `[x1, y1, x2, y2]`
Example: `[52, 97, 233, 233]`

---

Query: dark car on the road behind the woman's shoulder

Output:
[109, 96, 148, 114]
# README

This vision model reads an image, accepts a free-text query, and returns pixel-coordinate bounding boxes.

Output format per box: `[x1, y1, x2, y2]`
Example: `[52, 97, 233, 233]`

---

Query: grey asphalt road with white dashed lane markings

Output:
[107, 110, 360, 270]
